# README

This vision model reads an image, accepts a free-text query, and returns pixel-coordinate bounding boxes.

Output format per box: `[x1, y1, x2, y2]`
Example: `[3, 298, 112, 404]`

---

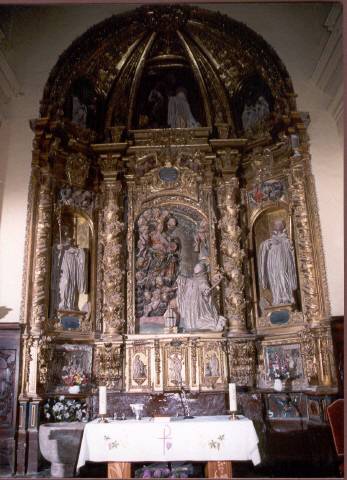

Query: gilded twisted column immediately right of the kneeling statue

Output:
[217, 149, 247, 336]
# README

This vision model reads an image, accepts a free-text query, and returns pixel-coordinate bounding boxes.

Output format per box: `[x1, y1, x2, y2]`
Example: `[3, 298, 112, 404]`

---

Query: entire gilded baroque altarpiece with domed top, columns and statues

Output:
[14, 6, 336, 474]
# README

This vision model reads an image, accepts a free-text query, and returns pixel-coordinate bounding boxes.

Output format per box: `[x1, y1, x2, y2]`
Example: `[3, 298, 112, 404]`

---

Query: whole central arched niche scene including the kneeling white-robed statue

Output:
[135, 205, 225, 333]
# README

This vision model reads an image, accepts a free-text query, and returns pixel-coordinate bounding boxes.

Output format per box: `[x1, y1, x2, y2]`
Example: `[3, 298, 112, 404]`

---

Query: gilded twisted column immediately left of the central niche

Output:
[99, 153, 125, 337]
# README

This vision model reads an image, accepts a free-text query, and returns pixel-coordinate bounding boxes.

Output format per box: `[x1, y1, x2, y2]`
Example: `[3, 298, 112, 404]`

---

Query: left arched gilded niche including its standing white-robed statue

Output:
[49, 202, 95, 334]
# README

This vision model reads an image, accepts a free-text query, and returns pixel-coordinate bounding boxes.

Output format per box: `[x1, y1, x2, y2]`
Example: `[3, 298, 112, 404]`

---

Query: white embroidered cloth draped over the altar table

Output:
[77, 415, 260, 470]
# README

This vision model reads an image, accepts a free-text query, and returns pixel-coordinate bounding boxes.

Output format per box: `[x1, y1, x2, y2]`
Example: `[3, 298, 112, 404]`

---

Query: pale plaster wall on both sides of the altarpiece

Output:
[0, 3, 343, 322]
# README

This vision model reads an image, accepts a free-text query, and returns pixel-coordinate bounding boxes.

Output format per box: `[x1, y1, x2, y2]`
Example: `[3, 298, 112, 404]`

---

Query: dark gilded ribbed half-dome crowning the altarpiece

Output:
[41, 6, 295, 137]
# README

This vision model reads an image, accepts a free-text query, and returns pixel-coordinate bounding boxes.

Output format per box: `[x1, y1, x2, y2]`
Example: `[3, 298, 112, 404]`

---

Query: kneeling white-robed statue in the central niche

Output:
[176, 263, 226, 332]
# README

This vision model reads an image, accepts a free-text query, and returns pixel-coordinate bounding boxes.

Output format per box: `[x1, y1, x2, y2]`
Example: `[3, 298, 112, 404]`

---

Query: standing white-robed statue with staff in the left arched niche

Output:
[51, 226, 88, 311]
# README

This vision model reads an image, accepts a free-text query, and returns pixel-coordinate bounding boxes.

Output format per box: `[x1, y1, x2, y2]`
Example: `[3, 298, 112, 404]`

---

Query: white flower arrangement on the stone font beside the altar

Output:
[43, 396, 88, 422]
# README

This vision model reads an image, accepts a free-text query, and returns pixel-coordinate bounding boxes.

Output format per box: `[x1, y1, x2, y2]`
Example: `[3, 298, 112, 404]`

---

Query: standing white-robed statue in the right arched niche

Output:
[258, 220, 297, 306]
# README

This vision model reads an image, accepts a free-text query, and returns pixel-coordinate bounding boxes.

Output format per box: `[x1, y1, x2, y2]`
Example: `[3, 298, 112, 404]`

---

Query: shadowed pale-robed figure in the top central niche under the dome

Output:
[167, 87, 200, 128]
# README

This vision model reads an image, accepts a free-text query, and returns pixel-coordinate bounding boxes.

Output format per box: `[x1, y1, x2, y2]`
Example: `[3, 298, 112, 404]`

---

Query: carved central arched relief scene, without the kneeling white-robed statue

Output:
[135, 204, 211, 334]
